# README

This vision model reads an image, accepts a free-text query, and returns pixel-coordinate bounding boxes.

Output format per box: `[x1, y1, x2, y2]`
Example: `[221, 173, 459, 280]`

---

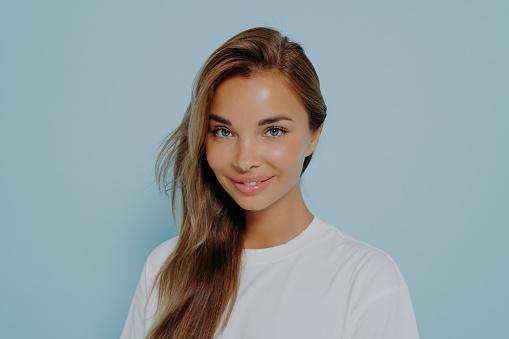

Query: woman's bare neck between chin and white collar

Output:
[244, 184, 313, 249]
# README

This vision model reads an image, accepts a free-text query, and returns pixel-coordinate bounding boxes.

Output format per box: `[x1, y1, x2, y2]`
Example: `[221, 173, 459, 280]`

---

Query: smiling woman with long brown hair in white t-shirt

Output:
[121, 28, 418, 339]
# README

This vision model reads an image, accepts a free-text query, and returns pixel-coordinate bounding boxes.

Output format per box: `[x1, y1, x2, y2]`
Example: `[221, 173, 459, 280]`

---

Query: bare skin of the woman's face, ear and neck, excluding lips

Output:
[206, 73, 321, 248]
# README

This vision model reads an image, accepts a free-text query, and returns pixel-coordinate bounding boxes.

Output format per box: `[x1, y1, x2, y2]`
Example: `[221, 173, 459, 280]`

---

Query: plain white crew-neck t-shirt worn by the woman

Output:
[120, 216, 419, 339]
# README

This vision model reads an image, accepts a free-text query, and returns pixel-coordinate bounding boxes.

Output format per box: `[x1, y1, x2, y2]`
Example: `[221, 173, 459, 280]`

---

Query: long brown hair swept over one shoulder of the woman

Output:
[147, 28, 326, 339]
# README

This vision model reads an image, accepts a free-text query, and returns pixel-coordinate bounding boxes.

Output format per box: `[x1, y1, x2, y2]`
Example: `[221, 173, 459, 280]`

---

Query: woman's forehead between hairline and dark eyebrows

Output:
[210, 73, 308, 123]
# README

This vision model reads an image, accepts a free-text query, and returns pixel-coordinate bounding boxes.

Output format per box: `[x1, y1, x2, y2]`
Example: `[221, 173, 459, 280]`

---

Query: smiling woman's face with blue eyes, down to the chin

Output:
[206, 73, 320, 210]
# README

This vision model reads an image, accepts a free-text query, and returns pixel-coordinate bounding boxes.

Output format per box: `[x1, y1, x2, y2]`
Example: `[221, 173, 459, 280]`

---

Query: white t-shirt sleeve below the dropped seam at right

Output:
[352, 288, 419, 339]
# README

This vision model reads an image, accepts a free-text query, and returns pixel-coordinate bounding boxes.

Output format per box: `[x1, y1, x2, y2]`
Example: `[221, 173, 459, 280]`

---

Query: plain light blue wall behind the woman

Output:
[0, 0, 509, 339]
